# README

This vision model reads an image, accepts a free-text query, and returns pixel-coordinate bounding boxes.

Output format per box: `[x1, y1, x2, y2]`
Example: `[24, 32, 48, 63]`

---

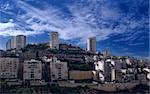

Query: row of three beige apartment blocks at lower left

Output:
[0, 56, 68, 85]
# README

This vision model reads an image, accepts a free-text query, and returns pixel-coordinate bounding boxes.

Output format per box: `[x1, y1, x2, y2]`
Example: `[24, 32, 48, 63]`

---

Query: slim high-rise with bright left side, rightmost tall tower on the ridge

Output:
[87, 37, 96, 53]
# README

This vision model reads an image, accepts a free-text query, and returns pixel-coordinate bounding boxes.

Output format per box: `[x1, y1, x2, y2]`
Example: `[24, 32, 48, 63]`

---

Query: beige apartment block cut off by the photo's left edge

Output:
[0, 57, 19, 79]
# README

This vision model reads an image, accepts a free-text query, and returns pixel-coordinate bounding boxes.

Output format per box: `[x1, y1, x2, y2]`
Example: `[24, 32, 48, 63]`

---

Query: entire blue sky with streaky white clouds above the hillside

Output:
[0, 0, 149, 58]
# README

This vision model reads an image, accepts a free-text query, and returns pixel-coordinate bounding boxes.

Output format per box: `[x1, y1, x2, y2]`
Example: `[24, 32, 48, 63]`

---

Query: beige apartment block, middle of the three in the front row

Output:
[23, 59, 42, 80]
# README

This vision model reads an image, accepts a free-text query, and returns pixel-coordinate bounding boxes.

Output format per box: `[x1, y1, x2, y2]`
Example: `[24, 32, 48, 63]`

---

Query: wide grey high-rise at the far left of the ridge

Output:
[6, 35, 26, 50]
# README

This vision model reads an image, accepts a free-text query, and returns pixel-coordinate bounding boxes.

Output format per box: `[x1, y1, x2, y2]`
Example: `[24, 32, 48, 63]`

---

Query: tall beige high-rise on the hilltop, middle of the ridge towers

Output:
[50, 32, 59, 49]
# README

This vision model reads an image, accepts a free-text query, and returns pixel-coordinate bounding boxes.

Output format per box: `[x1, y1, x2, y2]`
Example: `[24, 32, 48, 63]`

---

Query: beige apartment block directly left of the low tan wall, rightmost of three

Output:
[50, 58, 68, 81]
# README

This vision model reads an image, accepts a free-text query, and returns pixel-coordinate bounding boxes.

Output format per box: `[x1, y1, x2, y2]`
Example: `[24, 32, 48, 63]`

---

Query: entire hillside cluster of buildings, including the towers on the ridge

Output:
[0, 32, 150, 85]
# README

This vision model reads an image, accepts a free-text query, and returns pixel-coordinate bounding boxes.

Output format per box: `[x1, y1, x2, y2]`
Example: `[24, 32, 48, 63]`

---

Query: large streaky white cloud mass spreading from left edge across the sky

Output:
[0, 0, 148, 43]
